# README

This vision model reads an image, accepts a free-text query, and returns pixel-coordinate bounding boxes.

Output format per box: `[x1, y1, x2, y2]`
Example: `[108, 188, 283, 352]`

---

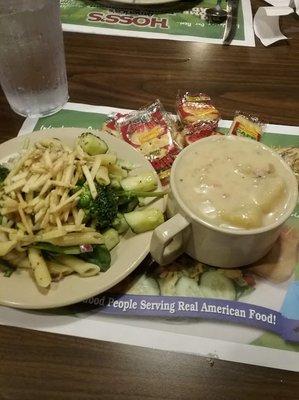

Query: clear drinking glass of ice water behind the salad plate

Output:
[0, 0, 69, 117]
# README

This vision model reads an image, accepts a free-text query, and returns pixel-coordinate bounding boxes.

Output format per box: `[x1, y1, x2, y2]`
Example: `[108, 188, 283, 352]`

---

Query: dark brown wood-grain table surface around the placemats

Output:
[0, 1, 299, 400]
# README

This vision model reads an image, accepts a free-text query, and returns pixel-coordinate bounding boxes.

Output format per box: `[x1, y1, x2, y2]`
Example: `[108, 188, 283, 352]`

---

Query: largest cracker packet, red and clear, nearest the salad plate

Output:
[116, 100, 181, 186]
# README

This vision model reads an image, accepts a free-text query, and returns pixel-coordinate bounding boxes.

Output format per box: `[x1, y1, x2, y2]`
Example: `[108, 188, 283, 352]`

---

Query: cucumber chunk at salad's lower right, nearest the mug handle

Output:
[124, 208, 164, 233]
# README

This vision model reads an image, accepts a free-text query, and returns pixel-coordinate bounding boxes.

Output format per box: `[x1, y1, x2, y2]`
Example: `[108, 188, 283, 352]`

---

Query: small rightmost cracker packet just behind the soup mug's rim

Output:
[229, 111, 264, 141]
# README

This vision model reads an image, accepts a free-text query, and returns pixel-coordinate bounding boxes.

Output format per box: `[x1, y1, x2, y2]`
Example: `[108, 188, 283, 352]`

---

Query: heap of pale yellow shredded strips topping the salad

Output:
[0, 139, 103, 285]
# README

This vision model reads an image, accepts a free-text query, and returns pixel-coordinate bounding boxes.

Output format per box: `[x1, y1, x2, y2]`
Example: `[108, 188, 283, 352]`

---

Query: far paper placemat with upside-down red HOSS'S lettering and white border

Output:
[60, 0, 255, 46]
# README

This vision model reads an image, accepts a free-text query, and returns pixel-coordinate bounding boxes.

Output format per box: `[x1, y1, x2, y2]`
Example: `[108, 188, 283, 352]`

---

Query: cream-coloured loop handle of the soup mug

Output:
[150, 214, 189, 265]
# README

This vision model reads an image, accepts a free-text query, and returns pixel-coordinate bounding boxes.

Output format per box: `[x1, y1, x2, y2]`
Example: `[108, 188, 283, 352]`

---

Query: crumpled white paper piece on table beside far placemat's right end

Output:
[253, 5, 299, 46]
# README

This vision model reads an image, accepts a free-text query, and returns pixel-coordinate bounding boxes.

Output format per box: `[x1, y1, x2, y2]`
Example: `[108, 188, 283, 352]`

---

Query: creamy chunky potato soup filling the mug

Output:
[176, 136, 288, 229]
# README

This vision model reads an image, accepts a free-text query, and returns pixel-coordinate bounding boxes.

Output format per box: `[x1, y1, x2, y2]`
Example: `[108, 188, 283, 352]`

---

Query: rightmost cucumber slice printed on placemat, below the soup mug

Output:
[199, 271, 236, 300]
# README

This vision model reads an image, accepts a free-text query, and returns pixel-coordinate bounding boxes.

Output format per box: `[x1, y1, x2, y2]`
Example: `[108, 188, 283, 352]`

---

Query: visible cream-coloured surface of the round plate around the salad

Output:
[0, 128, 165, 309]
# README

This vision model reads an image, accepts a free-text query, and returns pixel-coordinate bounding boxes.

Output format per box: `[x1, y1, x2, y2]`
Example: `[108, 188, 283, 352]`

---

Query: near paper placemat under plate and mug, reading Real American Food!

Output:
[0, 103, 299, 371]
